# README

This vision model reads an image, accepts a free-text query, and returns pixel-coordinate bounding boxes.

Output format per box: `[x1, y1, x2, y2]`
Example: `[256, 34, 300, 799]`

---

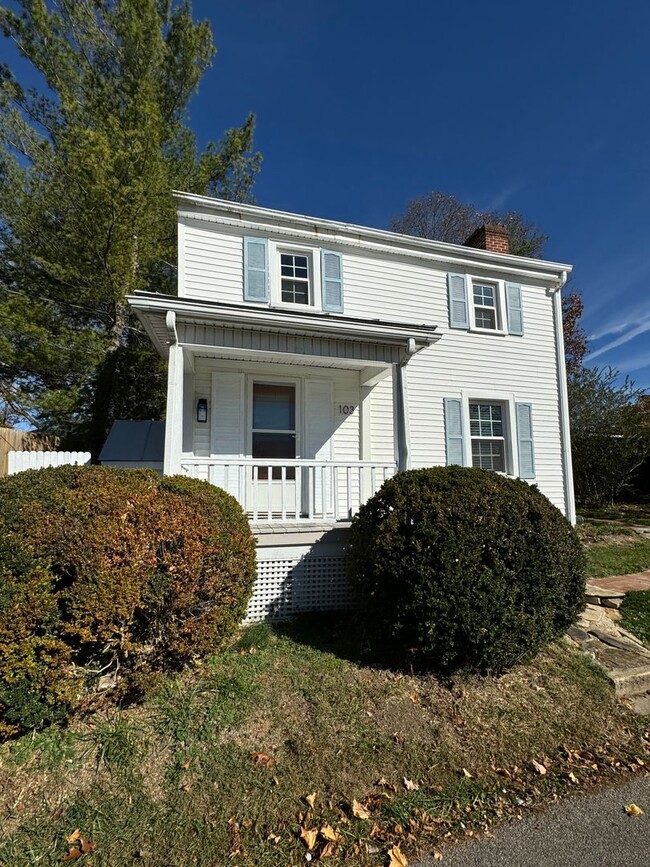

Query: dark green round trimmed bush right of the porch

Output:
[350, 466, 585, 673]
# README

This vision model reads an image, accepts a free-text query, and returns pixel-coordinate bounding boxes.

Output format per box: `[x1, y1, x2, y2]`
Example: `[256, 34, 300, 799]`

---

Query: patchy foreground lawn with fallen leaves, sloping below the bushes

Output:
[0, 618, 649, 867]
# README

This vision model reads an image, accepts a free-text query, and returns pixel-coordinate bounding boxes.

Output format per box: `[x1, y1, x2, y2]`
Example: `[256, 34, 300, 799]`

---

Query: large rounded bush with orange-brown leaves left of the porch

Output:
[0, 466, 255, 731]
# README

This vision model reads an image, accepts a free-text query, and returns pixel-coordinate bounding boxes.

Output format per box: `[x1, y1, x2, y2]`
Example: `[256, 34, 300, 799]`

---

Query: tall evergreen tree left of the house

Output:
[0, 0, 260, 451]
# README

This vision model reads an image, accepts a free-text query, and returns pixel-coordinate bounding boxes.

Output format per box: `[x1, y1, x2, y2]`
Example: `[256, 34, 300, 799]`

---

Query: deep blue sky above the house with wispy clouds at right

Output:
[191, 0, 650, 390]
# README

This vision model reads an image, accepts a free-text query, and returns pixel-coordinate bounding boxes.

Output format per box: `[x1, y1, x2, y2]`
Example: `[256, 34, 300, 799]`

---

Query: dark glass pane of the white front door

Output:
[253, 382, 296, 481]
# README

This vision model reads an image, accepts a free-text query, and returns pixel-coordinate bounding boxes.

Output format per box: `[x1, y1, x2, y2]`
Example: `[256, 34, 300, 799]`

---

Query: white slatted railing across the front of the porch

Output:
[181, 457, 397, 521]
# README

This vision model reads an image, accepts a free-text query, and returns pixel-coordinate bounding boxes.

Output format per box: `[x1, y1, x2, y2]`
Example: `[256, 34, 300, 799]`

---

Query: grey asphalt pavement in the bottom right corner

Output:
[420, 777, 650, 867]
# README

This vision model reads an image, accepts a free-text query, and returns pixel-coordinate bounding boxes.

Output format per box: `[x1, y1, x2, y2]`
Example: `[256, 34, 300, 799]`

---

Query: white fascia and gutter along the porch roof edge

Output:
[126, 294, 439, 346]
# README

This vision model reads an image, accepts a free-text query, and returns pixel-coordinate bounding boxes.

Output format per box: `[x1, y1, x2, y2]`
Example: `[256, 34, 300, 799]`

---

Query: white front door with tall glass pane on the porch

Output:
[248, 382, 298, 519]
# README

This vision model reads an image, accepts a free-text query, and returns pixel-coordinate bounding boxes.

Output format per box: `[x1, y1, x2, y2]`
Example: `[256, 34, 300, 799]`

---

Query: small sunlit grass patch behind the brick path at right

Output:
[577, 520, 650, 578]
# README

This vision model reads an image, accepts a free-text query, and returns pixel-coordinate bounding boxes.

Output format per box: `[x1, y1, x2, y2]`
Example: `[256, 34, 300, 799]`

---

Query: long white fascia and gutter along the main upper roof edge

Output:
[174, 192, 572, 283]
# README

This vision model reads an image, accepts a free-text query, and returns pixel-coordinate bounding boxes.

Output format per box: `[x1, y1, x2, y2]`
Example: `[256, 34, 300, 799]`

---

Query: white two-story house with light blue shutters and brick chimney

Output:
[129, 193, 575, 620]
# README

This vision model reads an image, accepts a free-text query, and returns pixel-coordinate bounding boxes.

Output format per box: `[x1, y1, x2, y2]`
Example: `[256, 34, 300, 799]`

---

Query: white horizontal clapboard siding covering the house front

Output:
[179, 227, 565, 510]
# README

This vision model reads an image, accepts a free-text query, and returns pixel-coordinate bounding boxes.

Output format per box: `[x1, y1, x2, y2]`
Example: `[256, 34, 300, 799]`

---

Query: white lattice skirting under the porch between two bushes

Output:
[244, 546, 350, 623]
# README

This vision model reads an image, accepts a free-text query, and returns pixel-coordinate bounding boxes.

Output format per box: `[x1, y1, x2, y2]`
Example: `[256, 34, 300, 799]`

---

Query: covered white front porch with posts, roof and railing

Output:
[130, 295, 435, 526]
